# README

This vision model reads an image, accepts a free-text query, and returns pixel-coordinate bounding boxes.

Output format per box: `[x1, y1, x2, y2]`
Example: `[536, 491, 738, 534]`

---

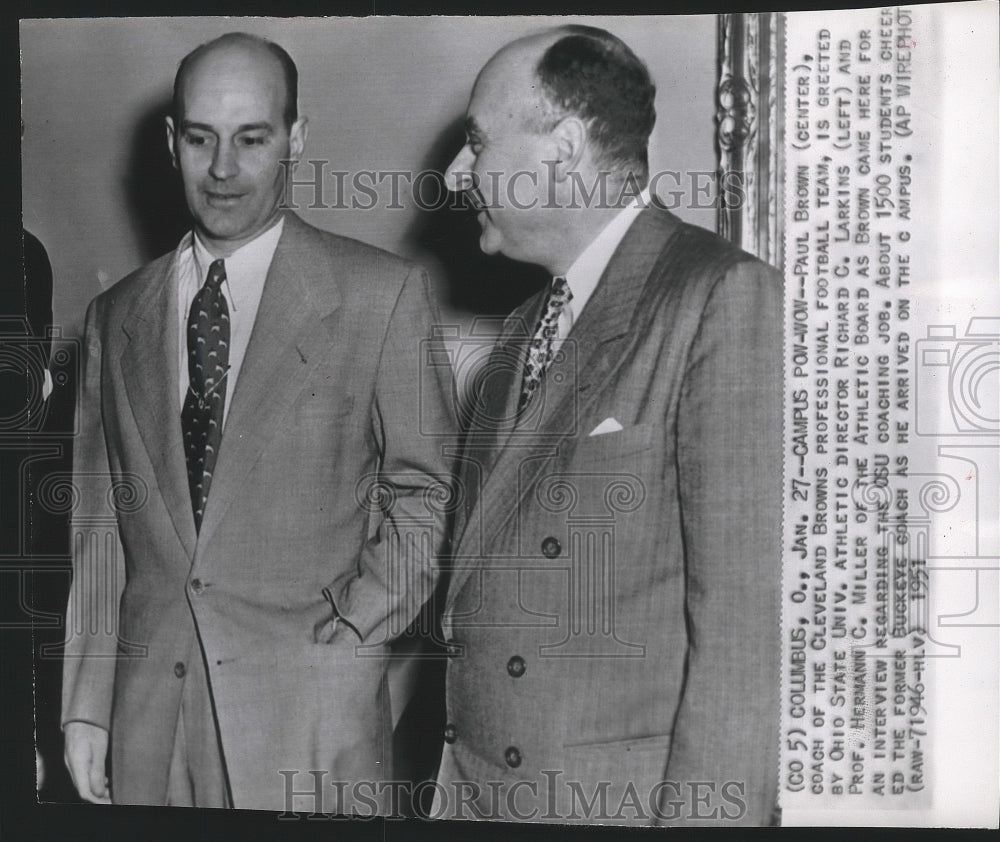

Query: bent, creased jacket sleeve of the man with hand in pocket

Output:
[331, 269, 457, 644]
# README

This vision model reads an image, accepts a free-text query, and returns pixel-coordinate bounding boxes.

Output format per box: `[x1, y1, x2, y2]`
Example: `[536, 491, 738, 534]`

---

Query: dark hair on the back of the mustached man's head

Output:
[535, 24, 656, 180]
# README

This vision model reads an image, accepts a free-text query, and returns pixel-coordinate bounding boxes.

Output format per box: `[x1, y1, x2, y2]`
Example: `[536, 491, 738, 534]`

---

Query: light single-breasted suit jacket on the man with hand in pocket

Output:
[62, 213, 452, 810]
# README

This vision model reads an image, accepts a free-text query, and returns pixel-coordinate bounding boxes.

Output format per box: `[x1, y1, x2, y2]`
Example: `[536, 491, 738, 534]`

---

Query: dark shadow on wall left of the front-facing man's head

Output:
[123, 97, 191, 264]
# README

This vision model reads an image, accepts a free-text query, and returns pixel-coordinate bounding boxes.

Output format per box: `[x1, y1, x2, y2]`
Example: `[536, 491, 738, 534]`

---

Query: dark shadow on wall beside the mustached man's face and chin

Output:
[404, 117, 549, 316]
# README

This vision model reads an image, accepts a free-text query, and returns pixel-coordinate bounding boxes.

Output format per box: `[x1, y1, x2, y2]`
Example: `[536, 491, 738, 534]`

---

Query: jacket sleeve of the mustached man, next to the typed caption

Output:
[666, 261, 783, 825]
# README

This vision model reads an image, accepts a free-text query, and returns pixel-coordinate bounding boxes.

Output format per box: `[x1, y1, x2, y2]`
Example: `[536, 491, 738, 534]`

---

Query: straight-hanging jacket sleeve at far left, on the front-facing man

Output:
[61, 300, 125, 730]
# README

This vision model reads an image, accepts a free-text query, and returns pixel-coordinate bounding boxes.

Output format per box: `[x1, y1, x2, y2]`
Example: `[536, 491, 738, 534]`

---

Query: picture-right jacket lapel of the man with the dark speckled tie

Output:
[198, 213, 339, 547]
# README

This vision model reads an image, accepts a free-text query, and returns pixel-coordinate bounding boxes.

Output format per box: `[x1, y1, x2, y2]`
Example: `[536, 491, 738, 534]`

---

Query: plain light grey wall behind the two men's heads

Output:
[21, 15, 716, 336]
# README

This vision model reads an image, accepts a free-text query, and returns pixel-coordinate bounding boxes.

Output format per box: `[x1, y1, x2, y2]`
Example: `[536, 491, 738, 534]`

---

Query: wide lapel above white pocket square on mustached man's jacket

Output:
[449, 207, 679, 603]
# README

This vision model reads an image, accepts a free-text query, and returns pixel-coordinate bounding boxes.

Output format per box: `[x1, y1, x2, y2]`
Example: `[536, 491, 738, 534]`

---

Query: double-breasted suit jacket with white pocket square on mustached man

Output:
[437, 205, 782, 824]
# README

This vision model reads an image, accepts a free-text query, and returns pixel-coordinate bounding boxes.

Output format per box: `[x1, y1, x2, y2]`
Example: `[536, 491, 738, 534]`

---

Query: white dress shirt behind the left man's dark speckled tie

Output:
[174, 219, 285, 427]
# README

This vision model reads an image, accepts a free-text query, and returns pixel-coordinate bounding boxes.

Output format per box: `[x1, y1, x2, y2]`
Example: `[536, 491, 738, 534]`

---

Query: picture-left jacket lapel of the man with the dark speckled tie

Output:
[121, 257, 196, 557]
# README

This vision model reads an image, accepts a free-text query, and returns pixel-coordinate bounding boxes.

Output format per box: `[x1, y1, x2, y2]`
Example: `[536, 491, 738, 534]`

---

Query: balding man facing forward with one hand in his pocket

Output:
[62, 34, 452, 812]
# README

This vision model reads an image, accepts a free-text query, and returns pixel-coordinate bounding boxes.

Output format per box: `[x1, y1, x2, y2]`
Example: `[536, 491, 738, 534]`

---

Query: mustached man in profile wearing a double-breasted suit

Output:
[435, 26, 782, 825]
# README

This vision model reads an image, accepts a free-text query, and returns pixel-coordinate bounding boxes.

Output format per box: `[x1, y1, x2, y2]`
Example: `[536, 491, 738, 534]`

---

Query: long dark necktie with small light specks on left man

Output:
[181, 260, 229, 531]
